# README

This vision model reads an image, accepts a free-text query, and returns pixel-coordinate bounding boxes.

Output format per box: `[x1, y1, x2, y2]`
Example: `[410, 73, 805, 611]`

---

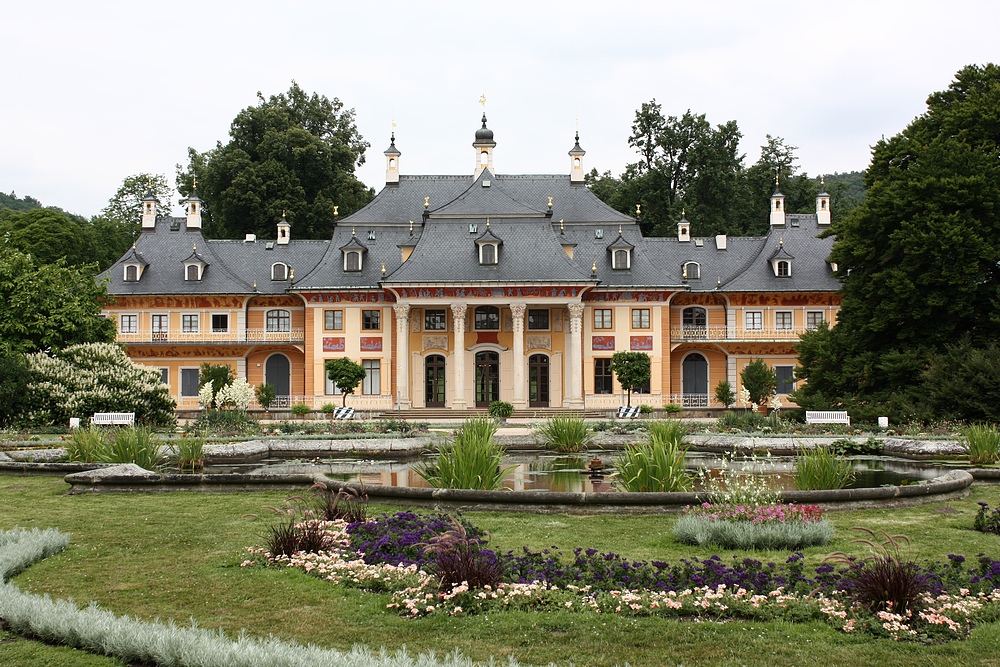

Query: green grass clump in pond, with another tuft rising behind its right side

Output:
[615, 421, 692, 492]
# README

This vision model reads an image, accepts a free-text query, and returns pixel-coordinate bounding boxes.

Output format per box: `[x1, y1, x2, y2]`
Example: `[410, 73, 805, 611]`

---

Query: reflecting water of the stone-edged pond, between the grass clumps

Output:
[205, 451, 951, 493]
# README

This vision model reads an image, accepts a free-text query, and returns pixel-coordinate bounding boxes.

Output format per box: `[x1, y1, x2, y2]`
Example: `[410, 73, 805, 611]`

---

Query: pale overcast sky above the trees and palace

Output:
[0, 0, 1000, 216]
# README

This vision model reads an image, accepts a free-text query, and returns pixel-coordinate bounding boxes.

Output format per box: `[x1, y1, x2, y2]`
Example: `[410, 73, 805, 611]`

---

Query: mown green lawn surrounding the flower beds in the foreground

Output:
[0, 475, 1000, 667]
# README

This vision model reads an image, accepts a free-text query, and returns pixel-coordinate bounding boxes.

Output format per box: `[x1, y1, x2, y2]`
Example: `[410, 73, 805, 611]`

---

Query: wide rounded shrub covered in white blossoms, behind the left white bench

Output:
[22, 343, 175, 425]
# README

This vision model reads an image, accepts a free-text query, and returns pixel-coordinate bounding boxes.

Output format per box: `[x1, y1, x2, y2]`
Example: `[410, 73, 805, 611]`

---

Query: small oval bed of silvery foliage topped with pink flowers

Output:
[674, 503, 833, 550]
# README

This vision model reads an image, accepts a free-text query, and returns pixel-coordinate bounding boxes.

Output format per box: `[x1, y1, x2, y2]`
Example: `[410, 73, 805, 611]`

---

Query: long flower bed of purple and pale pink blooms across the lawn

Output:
[243, 507, 1000, 641]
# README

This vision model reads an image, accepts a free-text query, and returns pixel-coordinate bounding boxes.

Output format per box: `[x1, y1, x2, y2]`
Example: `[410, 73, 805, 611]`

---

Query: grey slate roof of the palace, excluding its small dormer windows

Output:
[102, 129, 840, 295]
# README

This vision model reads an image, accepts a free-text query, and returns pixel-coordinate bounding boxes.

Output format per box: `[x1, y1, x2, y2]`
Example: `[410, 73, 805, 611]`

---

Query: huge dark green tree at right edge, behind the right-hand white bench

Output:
[800, 64, 1000, 419]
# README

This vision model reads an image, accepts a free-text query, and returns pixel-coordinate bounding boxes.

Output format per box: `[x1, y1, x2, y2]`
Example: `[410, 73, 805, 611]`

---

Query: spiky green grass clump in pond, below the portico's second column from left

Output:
[416, 417, 514, 491]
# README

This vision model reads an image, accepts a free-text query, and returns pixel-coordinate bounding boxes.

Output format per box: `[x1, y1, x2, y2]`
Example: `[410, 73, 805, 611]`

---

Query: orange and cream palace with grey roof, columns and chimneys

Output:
[102, 115, 840, 414]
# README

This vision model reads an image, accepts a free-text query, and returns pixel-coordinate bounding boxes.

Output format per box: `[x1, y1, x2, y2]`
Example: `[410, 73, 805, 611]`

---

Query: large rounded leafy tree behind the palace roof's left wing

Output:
[177, 81, 373, 238]
